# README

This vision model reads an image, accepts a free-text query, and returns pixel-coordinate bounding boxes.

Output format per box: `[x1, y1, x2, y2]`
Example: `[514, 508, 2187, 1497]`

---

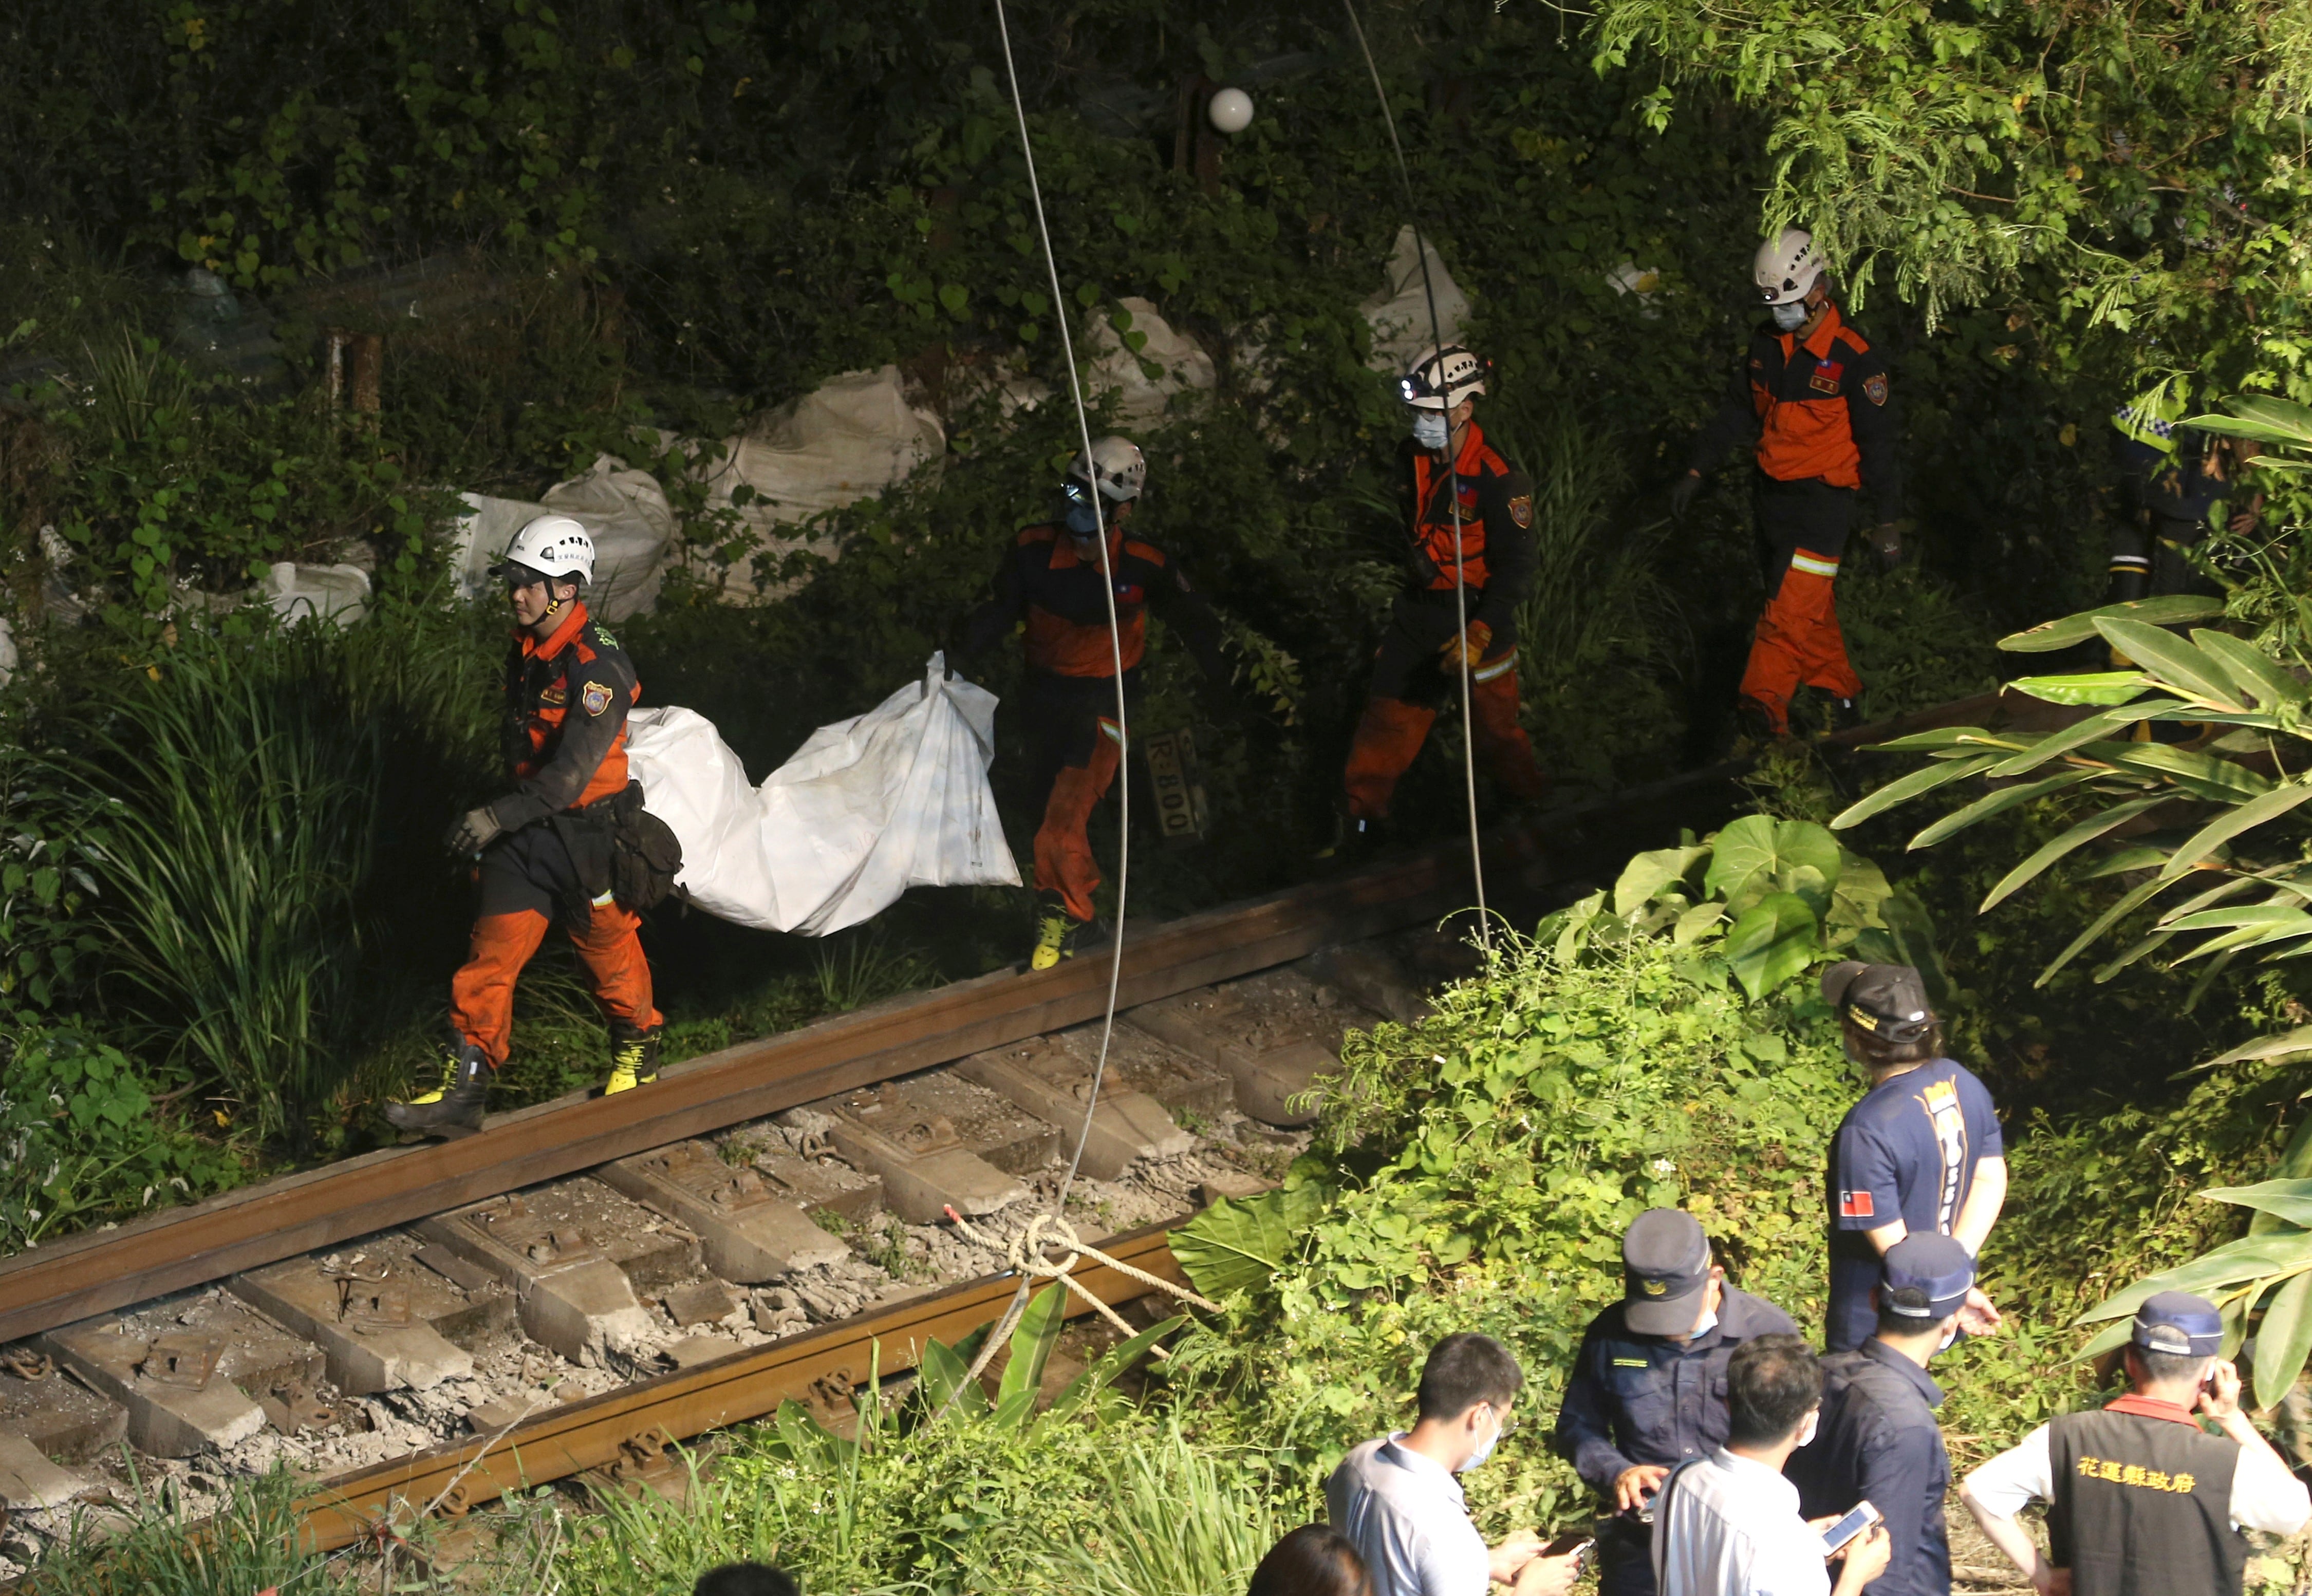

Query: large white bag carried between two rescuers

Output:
[627, 654, 1020, 937]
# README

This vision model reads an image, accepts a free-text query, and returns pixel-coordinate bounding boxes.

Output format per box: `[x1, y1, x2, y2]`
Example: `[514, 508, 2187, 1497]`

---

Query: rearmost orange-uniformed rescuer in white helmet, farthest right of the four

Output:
[1669, 227, 1903, 738]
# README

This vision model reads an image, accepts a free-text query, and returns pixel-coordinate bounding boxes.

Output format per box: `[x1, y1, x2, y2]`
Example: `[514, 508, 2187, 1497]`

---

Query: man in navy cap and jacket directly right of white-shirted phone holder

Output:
[1783, 1233, 1974, 1596]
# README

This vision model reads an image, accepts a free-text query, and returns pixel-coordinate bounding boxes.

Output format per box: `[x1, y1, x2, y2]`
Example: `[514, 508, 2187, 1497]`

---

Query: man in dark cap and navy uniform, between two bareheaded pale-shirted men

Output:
[1556, 1208, 1797, 1596]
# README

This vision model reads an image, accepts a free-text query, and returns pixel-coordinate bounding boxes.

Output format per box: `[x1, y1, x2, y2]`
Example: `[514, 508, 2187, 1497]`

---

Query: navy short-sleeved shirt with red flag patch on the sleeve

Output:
[1822, 1059, 2005, 1350]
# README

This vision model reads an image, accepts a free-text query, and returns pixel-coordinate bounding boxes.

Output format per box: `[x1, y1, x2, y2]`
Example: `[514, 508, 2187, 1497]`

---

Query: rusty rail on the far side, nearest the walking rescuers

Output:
[0, 765, 1739, 1342]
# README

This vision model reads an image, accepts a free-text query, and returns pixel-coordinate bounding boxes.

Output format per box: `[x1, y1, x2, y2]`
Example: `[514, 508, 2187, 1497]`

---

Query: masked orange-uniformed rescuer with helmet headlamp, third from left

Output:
[1320, 345, 1549, 858]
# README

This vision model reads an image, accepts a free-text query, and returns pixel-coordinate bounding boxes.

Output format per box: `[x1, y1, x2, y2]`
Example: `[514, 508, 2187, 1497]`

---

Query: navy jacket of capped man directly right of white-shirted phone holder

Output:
[1783, 1339, 1951, 1596]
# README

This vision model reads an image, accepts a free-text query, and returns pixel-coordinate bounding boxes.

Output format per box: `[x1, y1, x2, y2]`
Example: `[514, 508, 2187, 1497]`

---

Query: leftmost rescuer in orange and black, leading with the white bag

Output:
[386, 516, 661, 1136]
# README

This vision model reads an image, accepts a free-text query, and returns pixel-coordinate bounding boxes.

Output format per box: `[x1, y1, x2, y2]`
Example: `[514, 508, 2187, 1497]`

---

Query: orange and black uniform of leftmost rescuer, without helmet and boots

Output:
[451, 602, 661, 1068]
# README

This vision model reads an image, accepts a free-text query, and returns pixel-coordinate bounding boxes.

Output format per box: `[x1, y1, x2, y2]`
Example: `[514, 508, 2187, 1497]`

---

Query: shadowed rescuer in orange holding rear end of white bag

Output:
[957, 437, 1228, 969]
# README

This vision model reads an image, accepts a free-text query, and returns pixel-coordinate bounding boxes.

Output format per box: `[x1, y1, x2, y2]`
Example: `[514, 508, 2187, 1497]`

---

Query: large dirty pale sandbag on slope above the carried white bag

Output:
[705, 365, 948, 532]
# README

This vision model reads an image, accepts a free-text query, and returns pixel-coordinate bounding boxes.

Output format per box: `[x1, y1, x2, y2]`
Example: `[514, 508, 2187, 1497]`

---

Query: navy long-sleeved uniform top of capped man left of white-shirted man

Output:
[1556, 1286, 1797, 1496]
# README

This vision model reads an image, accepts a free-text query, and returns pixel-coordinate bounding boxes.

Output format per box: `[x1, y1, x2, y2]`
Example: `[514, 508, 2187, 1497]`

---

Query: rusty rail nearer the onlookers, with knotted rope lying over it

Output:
[299, 1222, 1186, 1552]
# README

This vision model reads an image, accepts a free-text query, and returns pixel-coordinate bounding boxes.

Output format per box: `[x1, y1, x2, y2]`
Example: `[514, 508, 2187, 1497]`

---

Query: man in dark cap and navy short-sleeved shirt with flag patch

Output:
[1822, 962, 2007, 1353]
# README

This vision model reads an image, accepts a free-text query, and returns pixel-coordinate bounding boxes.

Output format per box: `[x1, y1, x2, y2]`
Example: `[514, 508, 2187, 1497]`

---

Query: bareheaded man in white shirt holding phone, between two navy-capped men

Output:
[1653, 1335, 1894, 1596]
